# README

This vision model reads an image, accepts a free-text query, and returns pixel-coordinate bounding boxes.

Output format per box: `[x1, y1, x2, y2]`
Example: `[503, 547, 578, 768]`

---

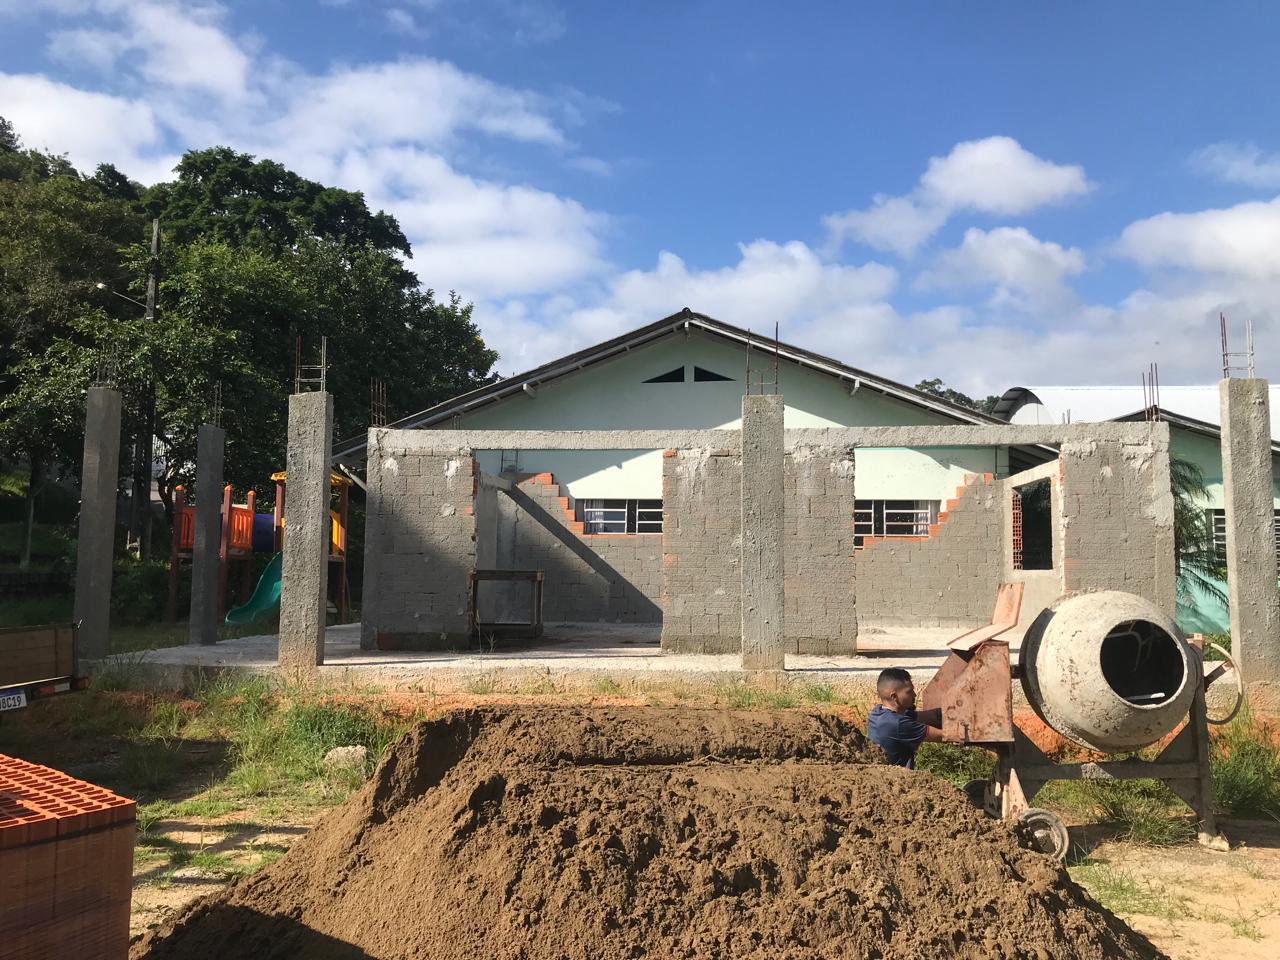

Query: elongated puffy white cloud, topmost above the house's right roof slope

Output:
[824, 137, 1093, 256]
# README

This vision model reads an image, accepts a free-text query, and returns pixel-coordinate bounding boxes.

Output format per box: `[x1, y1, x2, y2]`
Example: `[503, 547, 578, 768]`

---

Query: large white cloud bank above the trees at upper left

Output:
[0, 0, 607, 298]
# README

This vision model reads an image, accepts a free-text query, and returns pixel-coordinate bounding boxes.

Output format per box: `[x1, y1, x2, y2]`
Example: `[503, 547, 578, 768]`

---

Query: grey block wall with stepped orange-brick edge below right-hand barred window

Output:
[854, 474, 1009, 627]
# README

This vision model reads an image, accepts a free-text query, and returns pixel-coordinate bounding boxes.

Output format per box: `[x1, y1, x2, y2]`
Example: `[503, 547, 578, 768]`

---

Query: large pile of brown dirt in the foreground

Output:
[131, 707, 1160, 960]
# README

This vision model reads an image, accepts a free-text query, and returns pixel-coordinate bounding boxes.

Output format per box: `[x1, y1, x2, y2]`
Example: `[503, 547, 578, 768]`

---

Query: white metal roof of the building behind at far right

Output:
[1005, 384, 1280, 440]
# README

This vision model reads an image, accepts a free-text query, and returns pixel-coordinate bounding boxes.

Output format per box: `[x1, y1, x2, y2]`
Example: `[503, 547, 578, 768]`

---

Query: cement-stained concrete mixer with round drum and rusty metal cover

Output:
[920, 584, 1244, 858]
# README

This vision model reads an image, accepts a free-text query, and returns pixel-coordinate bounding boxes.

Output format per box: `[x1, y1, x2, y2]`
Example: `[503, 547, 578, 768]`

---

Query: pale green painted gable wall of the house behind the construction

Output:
[455, 332, 997, 500]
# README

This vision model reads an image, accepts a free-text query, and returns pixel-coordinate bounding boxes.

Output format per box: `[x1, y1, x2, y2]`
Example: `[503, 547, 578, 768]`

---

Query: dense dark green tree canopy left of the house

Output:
[0, 119, 497, 542]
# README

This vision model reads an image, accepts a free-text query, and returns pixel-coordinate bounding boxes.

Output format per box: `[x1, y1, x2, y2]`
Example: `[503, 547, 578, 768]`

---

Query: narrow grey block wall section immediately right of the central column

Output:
[782, 447, 858, 654]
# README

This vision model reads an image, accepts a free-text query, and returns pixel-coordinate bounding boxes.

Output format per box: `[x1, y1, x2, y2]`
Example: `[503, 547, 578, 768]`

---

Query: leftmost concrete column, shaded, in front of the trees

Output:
[74, 387, 120, 659]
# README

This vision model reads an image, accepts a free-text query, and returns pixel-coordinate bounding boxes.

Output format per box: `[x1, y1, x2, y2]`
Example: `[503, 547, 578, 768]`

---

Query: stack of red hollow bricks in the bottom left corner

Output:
[0, 754, 137, 960]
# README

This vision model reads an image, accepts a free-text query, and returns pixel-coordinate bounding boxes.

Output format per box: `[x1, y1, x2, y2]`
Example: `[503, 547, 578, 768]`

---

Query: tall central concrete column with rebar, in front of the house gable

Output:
[741, 393, 786, 669]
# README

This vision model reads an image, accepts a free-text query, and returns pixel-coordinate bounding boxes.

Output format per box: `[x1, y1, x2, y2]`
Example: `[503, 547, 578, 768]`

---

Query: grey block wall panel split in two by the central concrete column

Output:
[662, 448, 860, 654]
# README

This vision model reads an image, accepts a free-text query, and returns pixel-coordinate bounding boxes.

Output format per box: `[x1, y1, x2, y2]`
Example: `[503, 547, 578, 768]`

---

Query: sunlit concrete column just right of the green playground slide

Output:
[279, 393, 333, 678]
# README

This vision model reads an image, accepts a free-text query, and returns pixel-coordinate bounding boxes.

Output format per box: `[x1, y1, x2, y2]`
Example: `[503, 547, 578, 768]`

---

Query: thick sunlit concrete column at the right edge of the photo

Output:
[1219, 379, 1280, 710]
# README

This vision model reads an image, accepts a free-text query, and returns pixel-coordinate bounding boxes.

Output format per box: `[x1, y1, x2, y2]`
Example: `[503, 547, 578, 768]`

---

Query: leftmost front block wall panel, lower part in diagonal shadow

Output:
[361, 440, 479, 648]
